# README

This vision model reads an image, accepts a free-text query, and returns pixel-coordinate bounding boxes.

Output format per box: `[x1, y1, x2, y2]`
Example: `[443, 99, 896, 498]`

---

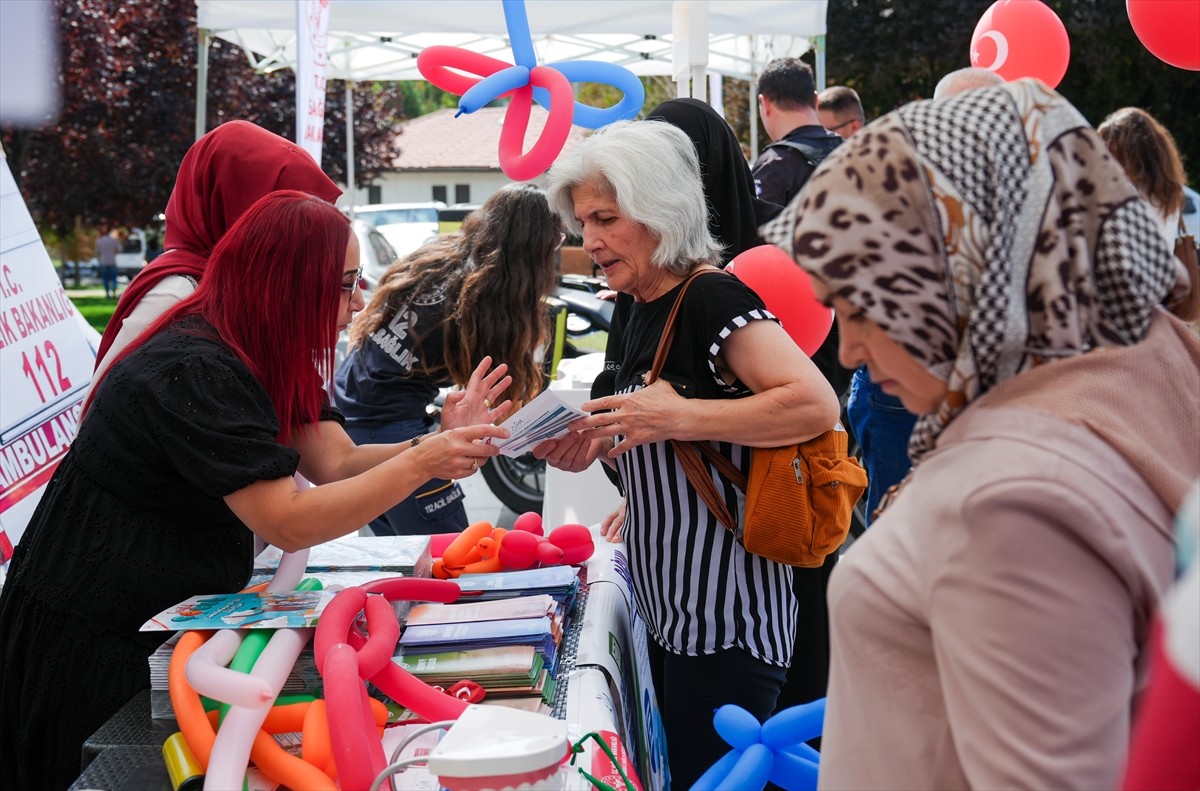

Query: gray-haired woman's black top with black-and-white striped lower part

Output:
[612, 276, 797, 665]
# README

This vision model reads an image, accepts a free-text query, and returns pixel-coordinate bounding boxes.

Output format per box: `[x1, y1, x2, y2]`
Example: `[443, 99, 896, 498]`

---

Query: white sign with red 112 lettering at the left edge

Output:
[0, 150, 100, 568]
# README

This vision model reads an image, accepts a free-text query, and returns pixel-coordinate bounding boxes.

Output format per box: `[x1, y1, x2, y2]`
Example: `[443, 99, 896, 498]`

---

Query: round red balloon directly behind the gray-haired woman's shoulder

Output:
[725, 245, 833, 356]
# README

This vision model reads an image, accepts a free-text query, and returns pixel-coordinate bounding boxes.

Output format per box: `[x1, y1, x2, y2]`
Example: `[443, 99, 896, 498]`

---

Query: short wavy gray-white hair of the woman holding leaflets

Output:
[546, 121, 721, 275]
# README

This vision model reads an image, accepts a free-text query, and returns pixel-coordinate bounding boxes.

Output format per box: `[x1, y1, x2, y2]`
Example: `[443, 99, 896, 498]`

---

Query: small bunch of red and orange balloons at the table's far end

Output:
[430, 511, 595, 580]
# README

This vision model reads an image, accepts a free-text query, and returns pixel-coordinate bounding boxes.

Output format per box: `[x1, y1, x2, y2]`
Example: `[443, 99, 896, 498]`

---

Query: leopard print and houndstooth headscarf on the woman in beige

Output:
[761, 80, 1182, 462]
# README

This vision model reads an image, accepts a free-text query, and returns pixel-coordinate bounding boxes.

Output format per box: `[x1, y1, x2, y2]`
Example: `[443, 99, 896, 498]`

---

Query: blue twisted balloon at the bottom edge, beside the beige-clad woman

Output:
[691, 697, 826, 791]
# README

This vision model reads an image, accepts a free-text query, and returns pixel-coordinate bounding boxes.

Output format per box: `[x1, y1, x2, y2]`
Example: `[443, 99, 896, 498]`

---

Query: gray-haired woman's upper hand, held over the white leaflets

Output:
[571, 379, 688, 459]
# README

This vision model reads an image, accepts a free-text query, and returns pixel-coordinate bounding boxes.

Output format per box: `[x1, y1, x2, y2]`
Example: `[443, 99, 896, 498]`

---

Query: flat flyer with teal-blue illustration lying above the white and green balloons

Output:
[140, 591, 335, 631]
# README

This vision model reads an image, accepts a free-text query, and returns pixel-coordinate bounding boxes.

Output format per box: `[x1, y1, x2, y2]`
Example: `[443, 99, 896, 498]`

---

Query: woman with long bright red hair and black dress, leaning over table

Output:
[0, 191, 509, 789]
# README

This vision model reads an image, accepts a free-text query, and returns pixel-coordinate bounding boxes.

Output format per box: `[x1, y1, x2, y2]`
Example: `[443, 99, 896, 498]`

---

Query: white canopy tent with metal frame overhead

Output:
[196, 0, 828, 181]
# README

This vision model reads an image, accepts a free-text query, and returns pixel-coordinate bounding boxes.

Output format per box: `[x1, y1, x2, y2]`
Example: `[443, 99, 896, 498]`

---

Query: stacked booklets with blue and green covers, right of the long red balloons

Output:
[396, 593, 566, 711]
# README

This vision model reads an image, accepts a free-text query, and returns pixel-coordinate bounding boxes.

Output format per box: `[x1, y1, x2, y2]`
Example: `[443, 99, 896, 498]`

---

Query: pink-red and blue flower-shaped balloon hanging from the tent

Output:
[416, 0, 646, 181]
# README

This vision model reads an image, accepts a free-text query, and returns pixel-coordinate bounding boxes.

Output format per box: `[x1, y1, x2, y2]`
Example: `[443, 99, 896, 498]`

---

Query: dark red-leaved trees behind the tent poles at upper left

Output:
[0, 0, 404, 260]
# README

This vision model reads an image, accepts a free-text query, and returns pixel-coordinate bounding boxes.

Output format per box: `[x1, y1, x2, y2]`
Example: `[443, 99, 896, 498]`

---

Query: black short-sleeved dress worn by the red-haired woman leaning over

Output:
[0, 318, 299, 791]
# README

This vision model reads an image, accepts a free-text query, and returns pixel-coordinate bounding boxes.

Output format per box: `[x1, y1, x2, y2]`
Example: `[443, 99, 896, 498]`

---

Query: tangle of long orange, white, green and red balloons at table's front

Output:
[168, 563, 468, 791]
